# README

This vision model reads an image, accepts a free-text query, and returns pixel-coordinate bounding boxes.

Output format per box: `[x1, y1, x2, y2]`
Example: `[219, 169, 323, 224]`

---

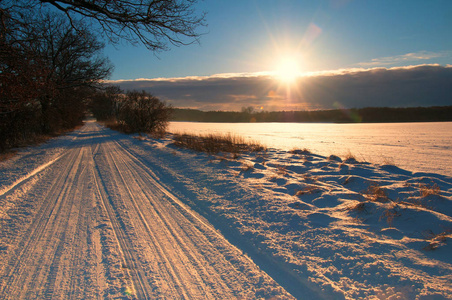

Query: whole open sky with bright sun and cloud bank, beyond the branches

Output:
[105, 0, 452, 110]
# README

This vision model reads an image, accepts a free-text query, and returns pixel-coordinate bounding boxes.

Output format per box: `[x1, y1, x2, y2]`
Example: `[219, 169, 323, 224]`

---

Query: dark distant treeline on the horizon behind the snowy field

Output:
[172, 106, 452, 123]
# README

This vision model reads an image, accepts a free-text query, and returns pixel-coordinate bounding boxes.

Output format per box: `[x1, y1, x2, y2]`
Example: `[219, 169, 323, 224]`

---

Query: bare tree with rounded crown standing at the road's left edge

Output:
[15, 13, 112, 132]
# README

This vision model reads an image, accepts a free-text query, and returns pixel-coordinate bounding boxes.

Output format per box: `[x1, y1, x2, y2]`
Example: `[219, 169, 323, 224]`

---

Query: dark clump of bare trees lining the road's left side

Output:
[0, 10, 111, 151]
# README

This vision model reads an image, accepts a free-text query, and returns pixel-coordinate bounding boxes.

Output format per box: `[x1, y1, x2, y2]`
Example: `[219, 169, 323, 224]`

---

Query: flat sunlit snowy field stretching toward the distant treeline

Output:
[169, 122, 452, 176]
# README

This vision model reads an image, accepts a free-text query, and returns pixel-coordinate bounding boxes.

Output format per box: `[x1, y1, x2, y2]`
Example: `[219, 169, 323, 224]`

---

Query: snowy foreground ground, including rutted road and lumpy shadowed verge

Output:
[0, 122, 452, 299]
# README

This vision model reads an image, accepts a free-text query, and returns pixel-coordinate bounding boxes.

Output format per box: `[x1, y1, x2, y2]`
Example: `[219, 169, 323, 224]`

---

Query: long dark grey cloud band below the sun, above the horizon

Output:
[109, 65, 452, 110]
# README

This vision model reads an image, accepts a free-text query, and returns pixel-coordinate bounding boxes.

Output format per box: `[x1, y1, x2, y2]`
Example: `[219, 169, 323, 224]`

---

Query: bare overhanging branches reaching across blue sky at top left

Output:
[0, 0, 204, 51]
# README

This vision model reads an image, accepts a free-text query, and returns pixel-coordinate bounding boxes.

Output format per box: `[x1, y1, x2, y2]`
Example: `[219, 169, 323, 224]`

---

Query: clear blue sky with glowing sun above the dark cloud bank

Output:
[105, 0, 452, 110]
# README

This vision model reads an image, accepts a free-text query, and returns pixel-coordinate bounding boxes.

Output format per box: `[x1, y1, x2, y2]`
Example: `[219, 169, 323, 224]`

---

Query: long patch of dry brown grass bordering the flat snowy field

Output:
[174, 134, 266, 154]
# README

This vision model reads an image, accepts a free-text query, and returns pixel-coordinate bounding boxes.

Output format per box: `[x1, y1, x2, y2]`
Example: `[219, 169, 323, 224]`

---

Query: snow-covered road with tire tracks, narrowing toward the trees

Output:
[0, 122, 291, 299]
